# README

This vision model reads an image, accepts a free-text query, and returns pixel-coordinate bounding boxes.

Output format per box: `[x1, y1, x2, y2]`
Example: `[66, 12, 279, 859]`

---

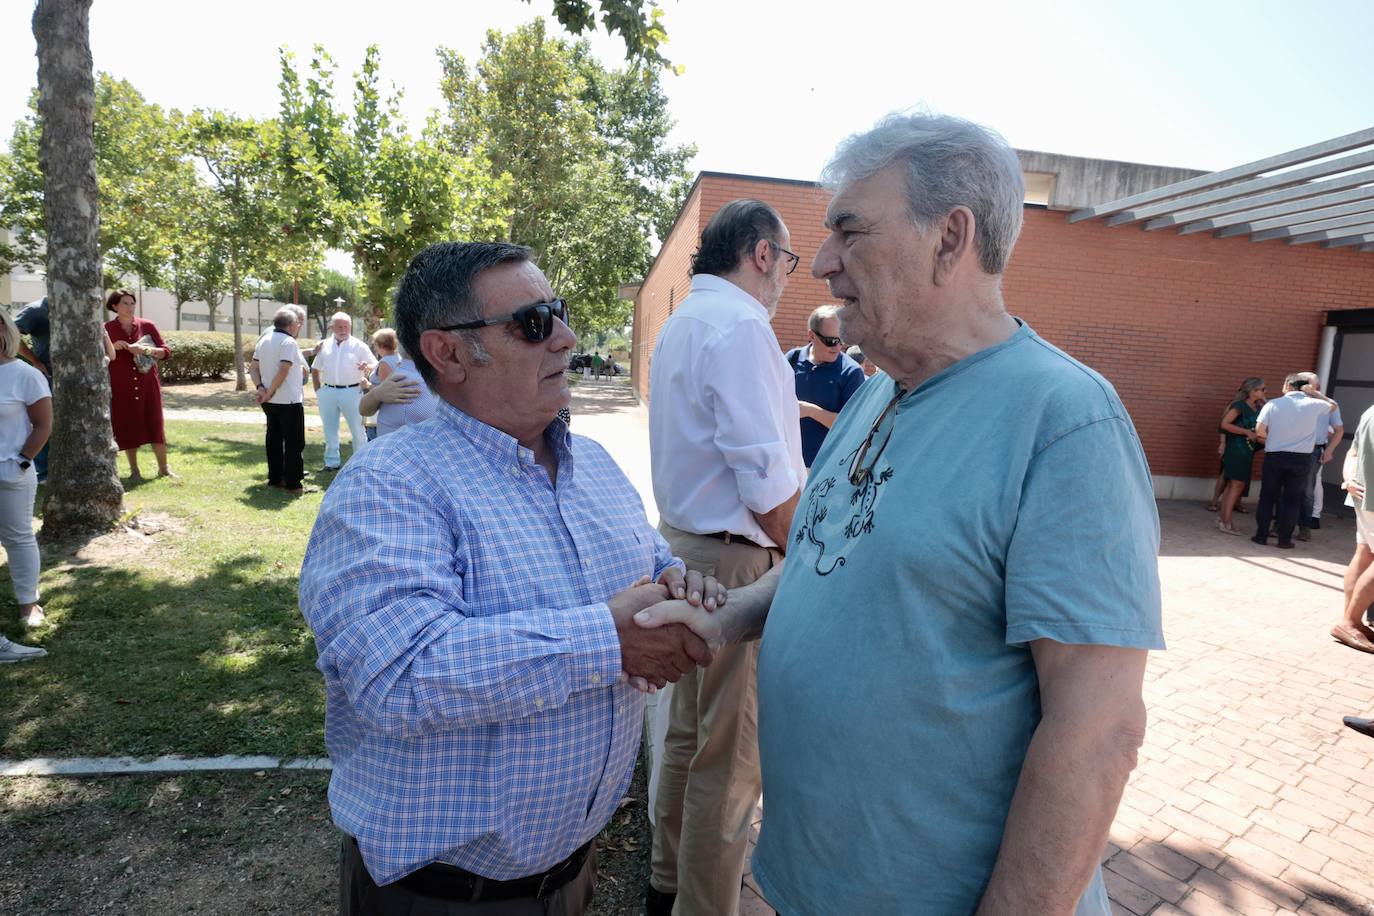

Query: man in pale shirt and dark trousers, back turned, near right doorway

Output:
[1250, 372, 1336, 549]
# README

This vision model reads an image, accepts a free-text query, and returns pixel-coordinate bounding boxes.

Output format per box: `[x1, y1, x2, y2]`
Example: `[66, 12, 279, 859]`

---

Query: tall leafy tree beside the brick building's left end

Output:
[438, 21, 695, 331]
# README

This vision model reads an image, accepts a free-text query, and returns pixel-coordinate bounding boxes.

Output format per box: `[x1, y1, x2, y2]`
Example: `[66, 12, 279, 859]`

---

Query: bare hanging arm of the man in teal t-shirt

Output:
[978, 645, 1147, 916]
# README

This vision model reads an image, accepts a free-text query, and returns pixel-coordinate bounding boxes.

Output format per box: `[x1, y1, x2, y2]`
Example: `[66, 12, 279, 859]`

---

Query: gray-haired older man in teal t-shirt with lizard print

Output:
[639, 115, 1164, 916]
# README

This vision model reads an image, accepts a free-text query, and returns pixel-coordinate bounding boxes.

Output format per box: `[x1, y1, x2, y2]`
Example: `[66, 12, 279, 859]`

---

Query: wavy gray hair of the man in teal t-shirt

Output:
[820, 114, 1025, 275]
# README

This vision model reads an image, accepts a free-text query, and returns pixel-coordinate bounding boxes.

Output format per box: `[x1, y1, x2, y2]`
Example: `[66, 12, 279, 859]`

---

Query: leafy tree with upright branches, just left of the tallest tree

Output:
[280, 47, 507, 327]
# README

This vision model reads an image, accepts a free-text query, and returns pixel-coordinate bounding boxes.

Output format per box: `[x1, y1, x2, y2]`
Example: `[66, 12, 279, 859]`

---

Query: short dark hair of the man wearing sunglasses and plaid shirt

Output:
[393, 242, 533, 385]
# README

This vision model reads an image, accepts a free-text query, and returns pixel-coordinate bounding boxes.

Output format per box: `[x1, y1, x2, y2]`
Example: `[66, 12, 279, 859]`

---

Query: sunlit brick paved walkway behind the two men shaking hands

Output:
[573, 386, 1374, 916]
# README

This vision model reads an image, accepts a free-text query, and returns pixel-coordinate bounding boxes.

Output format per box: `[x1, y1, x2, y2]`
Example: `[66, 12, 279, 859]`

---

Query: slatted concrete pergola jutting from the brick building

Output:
[1069, 128, 1374, 251]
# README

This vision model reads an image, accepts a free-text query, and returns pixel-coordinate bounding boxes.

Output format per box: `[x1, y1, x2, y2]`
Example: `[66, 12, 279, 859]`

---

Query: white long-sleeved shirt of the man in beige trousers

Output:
[649, 273, 805, 547]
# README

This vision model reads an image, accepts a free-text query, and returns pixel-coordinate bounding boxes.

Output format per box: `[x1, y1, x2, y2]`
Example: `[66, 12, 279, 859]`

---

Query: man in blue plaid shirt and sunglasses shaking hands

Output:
[301, 243, 725, 915]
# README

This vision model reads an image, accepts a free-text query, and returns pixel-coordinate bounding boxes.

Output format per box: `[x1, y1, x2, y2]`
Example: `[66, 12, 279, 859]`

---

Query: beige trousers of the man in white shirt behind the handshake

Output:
[651, 523, 782, 916]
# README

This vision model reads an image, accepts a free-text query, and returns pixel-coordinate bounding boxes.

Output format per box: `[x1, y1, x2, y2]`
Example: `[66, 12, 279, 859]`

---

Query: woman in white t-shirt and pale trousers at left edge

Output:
[0, 309, 52, 663]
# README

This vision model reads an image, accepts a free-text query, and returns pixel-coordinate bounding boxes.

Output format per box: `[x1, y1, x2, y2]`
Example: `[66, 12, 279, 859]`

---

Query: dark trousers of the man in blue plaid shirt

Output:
[339, 836, 596, 916]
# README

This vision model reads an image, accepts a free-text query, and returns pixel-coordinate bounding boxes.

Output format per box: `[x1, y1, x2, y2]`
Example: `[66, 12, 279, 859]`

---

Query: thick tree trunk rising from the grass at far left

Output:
[33, 0, 124, 541]
